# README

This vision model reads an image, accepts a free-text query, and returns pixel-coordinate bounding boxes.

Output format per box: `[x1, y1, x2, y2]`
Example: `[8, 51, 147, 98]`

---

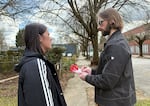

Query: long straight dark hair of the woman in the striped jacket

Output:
[24, 23, 47, 54]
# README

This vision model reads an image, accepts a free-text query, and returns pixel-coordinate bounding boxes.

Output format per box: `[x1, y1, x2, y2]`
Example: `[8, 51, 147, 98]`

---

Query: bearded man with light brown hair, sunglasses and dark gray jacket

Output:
[79, 8, 136, 106]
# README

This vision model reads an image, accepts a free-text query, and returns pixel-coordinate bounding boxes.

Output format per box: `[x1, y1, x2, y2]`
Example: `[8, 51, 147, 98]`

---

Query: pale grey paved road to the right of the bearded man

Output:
[132, 58, 150, 97]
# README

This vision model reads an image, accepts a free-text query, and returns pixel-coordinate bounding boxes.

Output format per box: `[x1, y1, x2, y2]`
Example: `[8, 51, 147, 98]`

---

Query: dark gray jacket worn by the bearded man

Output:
[85, 31, 136, 106]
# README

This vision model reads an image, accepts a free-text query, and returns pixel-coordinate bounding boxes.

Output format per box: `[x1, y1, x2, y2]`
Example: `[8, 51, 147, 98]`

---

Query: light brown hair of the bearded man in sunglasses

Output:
[99, 8, 123, 30]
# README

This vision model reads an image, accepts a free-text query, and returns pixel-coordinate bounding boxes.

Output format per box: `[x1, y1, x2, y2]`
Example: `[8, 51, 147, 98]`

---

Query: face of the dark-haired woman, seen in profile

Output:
[39, 30, 52, 53]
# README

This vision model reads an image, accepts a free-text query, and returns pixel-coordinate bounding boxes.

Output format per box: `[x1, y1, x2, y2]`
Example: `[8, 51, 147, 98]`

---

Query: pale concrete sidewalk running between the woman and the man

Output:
[64, 56, 94, 106]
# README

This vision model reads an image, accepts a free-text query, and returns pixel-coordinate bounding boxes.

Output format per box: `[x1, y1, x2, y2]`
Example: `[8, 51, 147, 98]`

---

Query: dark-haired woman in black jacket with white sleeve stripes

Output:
[15, 23, 67, 106]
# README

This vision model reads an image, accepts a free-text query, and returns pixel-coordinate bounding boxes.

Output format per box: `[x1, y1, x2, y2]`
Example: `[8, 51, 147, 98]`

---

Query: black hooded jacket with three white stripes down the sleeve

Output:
[15, 49, 67, 106]
